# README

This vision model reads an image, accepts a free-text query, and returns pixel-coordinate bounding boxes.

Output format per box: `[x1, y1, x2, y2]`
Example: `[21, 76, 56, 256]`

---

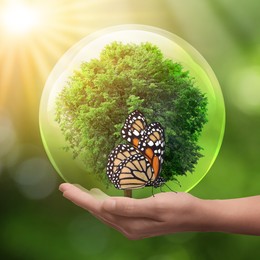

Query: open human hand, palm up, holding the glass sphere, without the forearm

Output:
[60, 183, 199, 239]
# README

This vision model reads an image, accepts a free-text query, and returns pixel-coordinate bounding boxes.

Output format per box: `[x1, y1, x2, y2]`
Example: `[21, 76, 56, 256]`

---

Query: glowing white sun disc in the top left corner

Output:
[3, 4, 41, 35]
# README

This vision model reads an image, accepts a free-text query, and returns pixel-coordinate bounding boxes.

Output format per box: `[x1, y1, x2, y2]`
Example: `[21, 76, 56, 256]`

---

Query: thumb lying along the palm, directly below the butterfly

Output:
[103, 197, 157, 220]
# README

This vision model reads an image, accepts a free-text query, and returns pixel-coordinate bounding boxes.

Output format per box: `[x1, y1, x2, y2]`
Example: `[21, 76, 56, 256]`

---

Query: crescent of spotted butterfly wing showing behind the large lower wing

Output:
[107, 144, 139, 182]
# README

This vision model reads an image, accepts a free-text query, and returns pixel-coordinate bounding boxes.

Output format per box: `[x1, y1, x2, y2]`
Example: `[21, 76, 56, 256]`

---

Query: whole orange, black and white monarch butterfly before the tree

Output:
[107, 110, 165, 190]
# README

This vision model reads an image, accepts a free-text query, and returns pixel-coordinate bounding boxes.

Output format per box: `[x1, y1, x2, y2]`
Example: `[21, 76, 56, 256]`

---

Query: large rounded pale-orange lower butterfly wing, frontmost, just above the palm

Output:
[112, 153, 154, 190]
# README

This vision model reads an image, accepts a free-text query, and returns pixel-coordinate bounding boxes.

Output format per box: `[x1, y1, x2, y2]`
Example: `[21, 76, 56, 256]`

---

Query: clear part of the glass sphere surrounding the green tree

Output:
[39, 25, 225, 197]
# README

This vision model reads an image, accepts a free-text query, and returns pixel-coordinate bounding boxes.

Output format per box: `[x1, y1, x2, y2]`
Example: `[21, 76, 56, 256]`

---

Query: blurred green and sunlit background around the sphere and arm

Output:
[0, 0, 260, 260]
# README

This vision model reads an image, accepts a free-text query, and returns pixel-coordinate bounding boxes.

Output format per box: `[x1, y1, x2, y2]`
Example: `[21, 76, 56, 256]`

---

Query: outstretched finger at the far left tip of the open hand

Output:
[60, 183, 102, 212]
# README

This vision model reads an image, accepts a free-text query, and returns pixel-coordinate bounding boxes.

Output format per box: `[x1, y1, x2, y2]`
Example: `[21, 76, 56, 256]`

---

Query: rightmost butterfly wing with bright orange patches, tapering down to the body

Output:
[138, 122, 165, 181]
